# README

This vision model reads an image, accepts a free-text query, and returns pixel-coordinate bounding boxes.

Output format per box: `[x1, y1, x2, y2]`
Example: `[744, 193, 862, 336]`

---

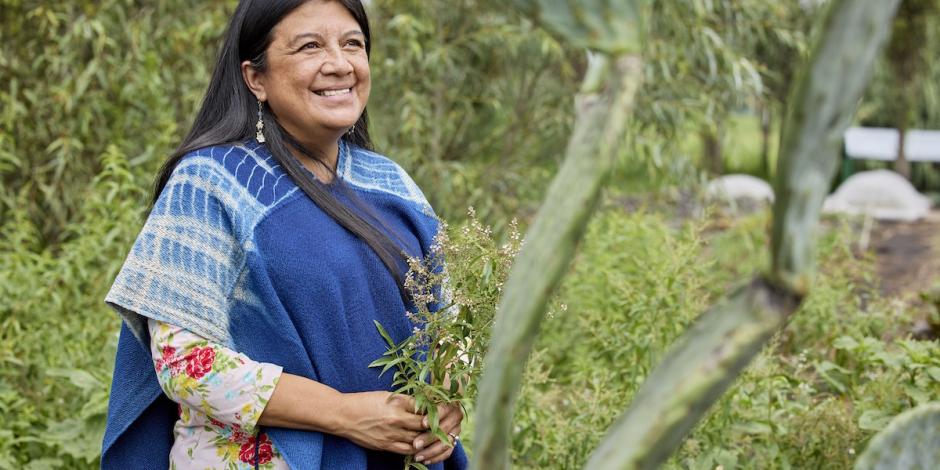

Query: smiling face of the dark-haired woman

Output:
[246, 0, 371, 145]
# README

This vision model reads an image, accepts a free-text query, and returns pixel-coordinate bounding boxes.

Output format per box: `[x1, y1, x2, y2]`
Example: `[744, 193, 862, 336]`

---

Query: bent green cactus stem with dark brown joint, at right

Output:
[585, 0, 900, 470]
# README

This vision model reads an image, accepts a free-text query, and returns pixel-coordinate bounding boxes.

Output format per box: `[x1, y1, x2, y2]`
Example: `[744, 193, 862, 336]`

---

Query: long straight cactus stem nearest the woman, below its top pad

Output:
[471, 55, 643, 470]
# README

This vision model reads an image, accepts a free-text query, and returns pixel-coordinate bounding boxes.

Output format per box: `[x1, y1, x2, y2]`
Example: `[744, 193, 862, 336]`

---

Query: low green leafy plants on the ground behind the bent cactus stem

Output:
[513, 208, 940, 469]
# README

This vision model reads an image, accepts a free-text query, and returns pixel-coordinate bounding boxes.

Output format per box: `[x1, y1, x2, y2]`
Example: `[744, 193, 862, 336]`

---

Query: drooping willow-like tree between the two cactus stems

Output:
[624, 0, 817, 175]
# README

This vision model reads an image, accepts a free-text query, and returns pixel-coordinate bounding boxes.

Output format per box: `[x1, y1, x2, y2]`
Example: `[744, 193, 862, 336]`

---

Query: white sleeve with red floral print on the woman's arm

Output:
[147, 319, 282, 435]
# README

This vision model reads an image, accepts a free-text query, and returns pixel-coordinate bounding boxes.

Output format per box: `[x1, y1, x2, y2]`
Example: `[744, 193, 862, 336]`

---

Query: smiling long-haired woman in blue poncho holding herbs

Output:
[102, 0, 466, 469]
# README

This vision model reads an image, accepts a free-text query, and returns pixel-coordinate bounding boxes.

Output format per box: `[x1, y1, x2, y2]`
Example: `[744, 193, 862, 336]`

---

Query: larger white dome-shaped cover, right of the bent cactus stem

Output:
[823, 170, 930, 222]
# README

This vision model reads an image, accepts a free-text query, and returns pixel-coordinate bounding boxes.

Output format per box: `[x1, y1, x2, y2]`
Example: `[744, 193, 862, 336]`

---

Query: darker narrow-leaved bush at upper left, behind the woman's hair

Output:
[0, 0, 228, 247]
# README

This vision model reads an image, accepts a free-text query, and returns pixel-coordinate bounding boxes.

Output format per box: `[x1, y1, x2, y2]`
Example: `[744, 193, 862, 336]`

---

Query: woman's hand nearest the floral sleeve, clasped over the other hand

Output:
[336, 392, 426, 455]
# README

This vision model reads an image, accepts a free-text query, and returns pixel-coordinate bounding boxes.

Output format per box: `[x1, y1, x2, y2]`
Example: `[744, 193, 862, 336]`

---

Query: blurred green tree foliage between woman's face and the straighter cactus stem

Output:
[369, 0, 585, 224]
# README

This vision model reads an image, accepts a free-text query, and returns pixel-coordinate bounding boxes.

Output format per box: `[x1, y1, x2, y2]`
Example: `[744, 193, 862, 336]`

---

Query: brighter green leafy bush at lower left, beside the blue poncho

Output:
[0, 146, 145, 468]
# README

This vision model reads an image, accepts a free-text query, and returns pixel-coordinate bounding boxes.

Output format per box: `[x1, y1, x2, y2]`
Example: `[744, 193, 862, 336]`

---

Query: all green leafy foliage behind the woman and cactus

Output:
[0, 0, 940, 468]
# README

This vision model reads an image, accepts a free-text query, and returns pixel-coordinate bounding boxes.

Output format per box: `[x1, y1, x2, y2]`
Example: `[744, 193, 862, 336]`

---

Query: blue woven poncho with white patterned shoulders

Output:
[101, 141, 467, 470]
